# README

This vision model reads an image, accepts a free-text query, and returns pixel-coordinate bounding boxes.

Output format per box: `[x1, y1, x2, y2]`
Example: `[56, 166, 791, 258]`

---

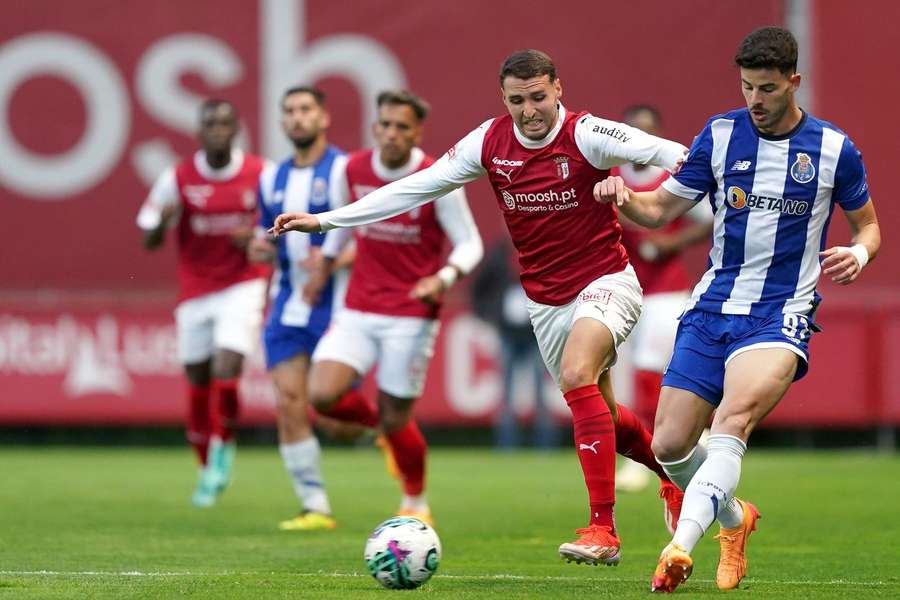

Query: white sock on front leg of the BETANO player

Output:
[672, 434, 747, 552]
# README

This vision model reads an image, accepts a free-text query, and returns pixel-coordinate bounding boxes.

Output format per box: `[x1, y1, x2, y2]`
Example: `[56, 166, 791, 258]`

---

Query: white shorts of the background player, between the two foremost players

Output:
[625, 290, 690, 373]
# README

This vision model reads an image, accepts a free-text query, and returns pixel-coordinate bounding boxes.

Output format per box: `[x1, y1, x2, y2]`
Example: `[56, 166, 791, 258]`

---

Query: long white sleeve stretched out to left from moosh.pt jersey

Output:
[316, 121, 491, 231]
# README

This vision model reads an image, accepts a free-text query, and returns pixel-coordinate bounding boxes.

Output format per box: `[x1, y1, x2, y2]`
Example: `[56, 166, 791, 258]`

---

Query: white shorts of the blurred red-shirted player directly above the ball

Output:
[312, 309, 441, 398]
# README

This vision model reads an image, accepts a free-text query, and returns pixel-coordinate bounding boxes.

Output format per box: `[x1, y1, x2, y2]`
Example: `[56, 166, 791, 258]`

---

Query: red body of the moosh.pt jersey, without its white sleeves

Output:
[481, 113, 628, 305]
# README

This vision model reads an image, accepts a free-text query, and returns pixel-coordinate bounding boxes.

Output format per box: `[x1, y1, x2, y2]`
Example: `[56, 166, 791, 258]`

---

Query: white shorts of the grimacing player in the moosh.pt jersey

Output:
[528, 265, 642, 385]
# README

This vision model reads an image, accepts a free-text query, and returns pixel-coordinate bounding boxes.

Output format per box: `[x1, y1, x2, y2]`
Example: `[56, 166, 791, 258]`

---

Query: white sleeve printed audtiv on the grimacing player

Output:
[575, 115, 687, 173]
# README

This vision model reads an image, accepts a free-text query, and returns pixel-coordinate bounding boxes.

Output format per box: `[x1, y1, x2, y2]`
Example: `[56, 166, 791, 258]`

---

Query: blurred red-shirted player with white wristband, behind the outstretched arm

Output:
[309, 90, 483, 522]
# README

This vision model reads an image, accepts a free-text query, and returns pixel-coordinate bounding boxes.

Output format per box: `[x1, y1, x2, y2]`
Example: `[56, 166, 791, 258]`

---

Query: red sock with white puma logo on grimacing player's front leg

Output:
[564, 384, 616, 531]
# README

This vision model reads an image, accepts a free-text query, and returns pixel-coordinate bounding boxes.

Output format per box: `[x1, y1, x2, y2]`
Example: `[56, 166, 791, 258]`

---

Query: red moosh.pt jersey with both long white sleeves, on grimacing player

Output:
[317, 106, 686, 306]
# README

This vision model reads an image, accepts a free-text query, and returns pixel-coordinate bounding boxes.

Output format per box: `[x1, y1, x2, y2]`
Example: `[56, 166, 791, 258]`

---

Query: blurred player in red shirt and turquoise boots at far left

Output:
[137, 100, 266, 506]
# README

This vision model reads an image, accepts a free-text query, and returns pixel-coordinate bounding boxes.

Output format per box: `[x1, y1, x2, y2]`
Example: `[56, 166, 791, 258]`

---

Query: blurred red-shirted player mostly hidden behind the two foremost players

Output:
[609, 105, 712, 491]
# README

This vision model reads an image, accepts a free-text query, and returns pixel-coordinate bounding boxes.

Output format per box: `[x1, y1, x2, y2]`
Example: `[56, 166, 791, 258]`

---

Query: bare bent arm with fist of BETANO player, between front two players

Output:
[594, 176, 696, 229]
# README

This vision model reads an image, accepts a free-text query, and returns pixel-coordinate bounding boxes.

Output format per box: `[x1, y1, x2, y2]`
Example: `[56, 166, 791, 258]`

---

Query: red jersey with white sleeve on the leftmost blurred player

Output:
[138, 150, 264, 301]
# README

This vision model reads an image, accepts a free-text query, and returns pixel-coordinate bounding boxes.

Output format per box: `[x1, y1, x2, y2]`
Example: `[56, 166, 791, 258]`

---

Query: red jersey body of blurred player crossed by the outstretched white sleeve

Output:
[345, 150, 447, 318]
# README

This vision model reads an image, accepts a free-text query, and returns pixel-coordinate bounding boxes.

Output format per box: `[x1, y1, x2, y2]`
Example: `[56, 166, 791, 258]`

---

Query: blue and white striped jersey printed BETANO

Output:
[663, 109, 869, 316]
